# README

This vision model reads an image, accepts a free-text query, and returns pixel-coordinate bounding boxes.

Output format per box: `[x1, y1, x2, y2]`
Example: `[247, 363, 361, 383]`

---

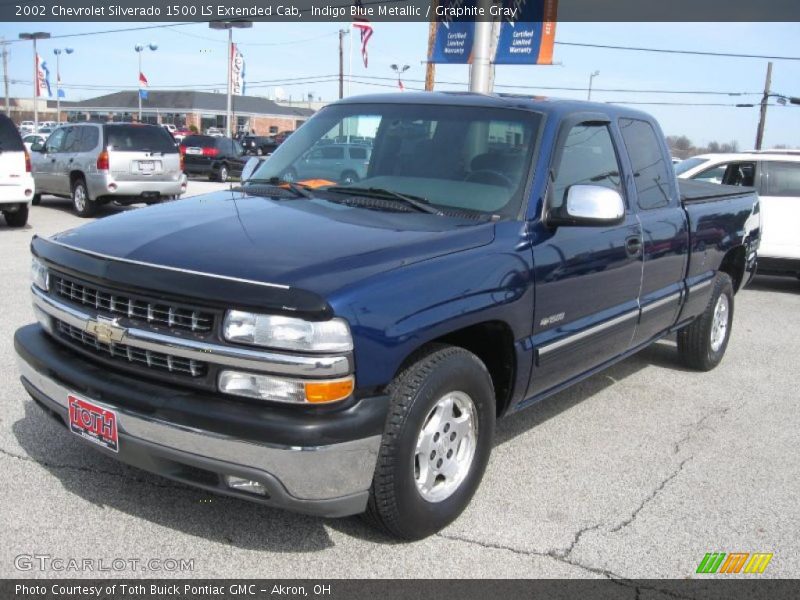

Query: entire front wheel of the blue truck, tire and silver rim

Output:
[365, 345, 495, 539]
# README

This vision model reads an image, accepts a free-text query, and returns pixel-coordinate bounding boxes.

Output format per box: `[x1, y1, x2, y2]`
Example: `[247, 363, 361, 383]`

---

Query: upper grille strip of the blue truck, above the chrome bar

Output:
[50, 273, 214, 333]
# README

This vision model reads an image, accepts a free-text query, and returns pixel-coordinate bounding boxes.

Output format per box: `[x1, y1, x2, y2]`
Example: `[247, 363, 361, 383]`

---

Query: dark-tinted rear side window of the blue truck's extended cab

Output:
[619, 119, 675, 210]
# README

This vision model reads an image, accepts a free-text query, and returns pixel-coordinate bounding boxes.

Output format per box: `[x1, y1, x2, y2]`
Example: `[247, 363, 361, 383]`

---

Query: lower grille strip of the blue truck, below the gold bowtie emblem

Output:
[56, 320, 208, 377]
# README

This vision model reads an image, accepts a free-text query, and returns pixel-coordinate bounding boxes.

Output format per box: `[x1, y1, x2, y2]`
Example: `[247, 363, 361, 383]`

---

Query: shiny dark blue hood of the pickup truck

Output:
[53, 191, 494, 297]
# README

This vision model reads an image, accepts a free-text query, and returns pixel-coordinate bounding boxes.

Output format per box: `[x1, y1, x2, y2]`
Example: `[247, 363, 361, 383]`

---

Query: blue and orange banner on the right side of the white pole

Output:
[494, 0, 558, 65]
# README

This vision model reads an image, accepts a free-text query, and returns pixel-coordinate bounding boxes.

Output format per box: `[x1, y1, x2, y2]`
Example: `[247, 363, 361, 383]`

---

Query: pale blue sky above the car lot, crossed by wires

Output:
[0, 23, 800, 149]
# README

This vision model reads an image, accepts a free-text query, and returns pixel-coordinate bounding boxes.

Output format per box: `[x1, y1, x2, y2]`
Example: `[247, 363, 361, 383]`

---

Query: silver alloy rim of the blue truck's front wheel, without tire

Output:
[413, 392, 478, 502]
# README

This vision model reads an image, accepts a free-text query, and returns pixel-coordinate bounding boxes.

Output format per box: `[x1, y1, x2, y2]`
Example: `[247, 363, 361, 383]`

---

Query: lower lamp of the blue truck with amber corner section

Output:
[219, 371, 355, 404]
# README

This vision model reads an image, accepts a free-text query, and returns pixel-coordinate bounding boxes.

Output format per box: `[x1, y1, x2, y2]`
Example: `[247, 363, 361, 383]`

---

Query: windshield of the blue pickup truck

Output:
[251, 104, 542, 216]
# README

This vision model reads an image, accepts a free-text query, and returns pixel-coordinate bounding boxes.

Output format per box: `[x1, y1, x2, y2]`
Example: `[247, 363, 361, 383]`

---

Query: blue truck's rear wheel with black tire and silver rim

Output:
[678, 273, 733, 371]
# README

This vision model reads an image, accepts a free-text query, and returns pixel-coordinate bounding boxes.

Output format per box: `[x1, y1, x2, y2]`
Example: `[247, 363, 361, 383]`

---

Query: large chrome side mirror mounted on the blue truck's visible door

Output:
[547, 185, 625, 227]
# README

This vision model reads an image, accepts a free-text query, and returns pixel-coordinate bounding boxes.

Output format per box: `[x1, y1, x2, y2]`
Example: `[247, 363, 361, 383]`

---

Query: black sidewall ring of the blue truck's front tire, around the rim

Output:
[393, 353, 495, 537]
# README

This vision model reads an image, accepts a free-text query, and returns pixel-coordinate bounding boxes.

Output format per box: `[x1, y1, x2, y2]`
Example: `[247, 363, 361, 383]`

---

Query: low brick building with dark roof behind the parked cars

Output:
[61, 90, 314, 135]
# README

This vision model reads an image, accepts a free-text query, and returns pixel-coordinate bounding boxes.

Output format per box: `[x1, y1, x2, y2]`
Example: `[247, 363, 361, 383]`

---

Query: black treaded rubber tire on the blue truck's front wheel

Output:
[364, 344, 495, 540]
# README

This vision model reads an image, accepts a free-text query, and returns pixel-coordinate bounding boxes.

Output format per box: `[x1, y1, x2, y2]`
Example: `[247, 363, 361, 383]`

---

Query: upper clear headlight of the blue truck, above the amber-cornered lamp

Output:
[222, 310, 353, 352]
